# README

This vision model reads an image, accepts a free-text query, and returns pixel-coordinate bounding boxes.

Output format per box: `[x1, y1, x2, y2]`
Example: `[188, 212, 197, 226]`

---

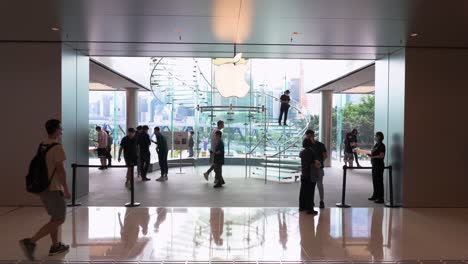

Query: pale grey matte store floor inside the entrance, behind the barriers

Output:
[78, 166, 381, 207]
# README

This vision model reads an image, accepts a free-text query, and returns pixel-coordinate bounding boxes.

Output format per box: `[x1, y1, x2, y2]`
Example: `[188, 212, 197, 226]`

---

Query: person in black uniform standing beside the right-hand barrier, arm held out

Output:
[368, 132, 385, 203]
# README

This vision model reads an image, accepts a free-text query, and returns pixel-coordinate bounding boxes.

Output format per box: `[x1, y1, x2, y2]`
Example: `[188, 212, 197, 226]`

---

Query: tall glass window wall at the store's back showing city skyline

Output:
[90, 58, 369, 175]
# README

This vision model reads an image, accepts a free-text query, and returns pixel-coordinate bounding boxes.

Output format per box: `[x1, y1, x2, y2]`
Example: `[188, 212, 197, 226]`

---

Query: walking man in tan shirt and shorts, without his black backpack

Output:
[19, 119, 71, 261]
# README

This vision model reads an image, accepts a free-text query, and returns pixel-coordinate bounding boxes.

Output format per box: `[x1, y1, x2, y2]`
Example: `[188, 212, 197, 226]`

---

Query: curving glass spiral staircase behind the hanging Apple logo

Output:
[151, 58, 311, 182]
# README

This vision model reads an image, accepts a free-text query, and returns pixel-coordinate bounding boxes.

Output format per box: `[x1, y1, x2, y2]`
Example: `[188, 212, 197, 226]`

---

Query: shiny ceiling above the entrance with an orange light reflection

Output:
[0, 0, 468, 59]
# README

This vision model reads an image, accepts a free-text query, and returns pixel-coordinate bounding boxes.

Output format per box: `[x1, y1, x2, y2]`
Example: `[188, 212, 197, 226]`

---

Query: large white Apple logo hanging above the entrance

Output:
[215, 53, 250, 98]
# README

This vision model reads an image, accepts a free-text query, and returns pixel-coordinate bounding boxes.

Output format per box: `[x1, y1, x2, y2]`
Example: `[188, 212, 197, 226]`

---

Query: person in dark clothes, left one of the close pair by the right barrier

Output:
[299, 139, 320, 215]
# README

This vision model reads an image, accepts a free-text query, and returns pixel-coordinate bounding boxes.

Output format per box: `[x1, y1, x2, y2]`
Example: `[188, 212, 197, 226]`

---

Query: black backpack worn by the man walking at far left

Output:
[26, 143, 60, 193]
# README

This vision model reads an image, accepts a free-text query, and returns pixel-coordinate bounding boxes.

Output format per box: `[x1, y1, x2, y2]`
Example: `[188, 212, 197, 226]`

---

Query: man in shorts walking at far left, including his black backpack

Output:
[19, 119, 71, 260]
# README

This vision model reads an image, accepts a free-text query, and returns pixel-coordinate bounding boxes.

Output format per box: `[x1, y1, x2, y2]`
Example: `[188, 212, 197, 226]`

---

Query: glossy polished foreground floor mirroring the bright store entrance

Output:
[0, 207, 468, 263]
